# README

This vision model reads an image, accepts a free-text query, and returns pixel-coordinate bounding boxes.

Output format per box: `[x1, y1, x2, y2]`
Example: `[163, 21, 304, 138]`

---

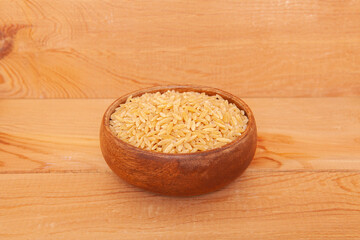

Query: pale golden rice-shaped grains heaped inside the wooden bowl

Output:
[110, 91, 248, 153]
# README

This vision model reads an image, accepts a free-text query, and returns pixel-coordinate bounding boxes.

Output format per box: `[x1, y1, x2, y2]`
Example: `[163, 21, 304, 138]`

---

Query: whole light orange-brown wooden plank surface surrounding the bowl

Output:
[0, 0, 360, 240]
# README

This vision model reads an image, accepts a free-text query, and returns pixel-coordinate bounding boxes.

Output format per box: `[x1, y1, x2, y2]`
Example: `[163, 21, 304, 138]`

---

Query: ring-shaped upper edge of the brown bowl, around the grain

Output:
[103, 85, 255, 156]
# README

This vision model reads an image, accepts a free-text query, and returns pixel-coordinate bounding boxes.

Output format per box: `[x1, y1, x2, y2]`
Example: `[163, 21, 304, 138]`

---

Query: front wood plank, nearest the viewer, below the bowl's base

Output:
[0, 171, 360, 240]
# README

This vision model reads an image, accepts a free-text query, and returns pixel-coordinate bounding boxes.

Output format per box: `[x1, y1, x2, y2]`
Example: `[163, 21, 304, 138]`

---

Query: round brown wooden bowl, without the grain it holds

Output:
[100, 86, 257, 196]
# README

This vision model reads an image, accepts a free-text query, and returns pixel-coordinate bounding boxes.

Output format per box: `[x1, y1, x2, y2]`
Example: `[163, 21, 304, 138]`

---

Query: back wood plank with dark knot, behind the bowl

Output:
[0, 0, 360, 98]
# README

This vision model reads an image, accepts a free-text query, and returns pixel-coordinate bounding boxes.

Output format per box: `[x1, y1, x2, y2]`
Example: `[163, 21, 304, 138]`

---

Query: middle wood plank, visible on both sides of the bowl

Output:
[0, 98, 360, 173]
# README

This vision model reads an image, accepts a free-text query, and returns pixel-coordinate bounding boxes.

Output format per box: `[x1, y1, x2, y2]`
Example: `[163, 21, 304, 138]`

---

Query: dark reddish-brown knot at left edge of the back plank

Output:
[0, 24, 29, 59]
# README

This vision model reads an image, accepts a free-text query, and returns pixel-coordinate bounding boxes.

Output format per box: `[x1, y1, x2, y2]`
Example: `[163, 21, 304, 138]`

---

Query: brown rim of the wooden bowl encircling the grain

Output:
[102, 84, 256, 158]
